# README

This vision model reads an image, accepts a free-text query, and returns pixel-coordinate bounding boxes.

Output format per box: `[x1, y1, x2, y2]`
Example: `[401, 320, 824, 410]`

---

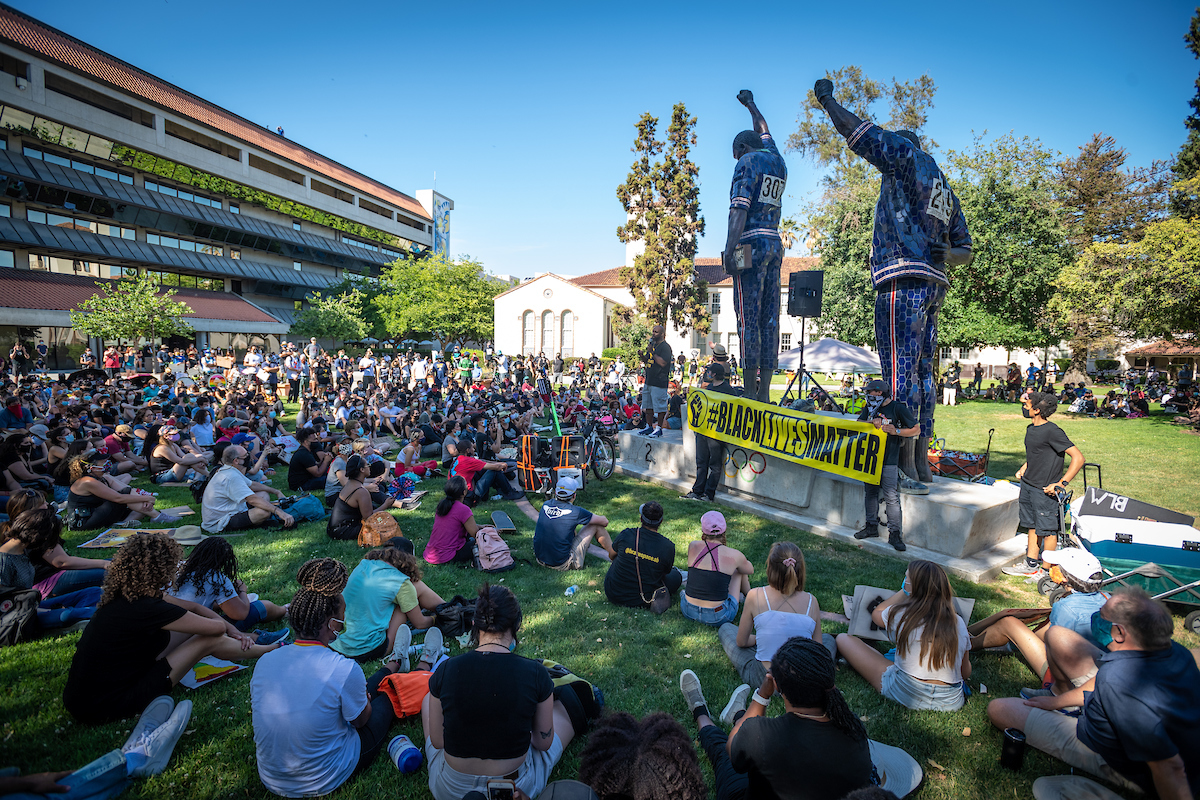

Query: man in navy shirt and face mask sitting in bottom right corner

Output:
[988, 589, 1200, 799]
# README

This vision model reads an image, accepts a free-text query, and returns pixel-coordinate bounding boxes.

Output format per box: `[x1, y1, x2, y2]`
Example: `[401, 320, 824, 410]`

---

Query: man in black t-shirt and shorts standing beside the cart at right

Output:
[1004, 392, 1084, 577]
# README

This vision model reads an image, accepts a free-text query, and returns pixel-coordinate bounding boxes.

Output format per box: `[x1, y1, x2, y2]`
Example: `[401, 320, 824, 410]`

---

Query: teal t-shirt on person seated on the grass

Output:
[329, 559, 416, 657]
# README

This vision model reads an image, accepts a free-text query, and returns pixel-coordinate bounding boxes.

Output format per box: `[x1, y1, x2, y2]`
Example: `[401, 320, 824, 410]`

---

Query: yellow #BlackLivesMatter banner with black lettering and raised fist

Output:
[688, 389, 887, 485]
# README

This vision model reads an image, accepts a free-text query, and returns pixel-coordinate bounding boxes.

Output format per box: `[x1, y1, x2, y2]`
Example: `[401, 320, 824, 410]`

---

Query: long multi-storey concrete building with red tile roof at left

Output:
[0, 6, 454, 369]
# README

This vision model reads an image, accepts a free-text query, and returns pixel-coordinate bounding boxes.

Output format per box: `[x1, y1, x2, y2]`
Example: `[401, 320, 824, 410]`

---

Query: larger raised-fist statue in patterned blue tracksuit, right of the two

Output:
[812, 78, 972, 493]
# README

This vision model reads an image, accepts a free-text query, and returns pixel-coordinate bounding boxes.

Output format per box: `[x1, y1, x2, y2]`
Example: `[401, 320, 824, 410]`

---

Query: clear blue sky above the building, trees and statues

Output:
[10, 0, 1200, 276]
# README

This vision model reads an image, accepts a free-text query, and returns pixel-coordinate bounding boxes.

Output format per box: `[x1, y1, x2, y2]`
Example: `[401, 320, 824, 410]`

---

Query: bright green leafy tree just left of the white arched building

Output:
[374, 255, 508, 345]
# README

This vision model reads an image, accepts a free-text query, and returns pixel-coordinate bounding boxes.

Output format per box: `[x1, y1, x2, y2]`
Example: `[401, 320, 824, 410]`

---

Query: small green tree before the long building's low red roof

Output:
[71, 275, 192, 342]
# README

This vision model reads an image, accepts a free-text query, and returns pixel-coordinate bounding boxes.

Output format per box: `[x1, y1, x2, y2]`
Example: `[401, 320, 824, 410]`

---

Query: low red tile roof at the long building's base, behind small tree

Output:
[0, 269, 280, 323]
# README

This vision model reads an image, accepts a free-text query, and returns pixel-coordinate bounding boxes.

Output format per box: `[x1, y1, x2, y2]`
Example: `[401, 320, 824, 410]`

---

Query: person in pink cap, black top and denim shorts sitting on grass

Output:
[679, 511, 753, 626]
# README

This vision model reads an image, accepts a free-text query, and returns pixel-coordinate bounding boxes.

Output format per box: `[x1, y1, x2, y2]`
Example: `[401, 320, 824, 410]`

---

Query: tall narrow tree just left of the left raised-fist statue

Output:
[617, 103, 709, 333]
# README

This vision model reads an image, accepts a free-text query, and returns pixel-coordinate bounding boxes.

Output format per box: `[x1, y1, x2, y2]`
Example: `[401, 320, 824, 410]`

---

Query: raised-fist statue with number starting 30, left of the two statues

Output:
[721, 89, 787, 403]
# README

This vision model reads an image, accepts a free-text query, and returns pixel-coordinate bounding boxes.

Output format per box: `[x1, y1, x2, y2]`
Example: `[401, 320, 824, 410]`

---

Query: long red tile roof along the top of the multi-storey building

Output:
[0, 7, 432, 221]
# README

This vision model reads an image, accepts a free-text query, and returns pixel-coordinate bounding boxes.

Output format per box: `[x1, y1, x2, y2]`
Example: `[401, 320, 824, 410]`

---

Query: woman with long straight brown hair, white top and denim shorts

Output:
[838, 561, 971, 711]
